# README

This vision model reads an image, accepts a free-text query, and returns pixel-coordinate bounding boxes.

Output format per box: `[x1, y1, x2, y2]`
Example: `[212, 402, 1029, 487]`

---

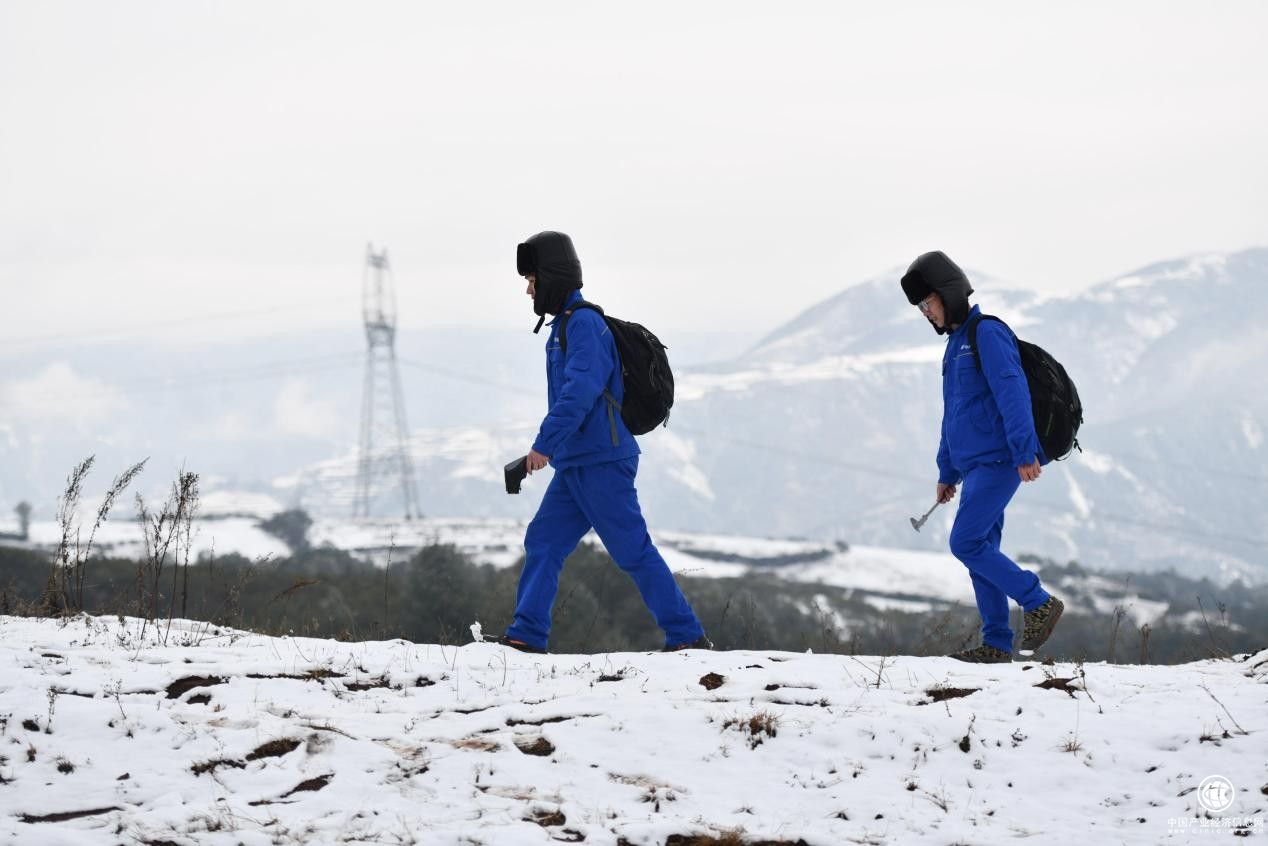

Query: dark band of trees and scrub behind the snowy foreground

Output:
[0, 540, 1268, 663]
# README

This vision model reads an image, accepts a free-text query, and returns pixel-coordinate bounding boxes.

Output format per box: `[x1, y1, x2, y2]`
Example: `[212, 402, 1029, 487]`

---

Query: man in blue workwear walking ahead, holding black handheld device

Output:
[498, 232, 713, 653]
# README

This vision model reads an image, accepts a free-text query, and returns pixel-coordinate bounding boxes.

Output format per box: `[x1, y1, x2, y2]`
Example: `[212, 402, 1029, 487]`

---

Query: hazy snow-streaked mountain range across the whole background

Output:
[0, 249, 1268, 587]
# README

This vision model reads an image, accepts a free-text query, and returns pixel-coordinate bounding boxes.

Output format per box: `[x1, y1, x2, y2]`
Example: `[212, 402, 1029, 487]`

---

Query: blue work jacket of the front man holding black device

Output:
[533, 290, 639, 471]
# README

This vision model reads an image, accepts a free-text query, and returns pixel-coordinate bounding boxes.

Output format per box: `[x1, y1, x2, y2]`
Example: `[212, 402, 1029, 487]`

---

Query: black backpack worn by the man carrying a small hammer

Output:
[969, 315, 1083, 462]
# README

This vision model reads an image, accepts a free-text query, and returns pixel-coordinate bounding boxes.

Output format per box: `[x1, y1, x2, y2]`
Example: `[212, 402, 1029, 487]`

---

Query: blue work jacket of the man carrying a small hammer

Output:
[937, 306, 1049, 485]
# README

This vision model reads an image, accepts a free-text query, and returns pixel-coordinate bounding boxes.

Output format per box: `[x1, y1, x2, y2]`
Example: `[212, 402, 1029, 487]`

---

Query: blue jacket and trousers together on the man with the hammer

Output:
[937, 306, 1049, 652]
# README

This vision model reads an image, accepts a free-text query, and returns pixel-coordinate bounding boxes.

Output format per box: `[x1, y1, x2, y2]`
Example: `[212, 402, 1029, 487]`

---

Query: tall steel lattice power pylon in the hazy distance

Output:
[353, 244, 422, 520]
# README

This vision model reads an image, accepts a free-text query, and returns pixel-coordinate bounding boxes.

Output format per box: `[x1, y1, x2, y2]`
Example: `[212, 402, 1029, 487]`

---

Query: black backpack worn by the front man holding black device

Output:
[559, 302, 673, 443]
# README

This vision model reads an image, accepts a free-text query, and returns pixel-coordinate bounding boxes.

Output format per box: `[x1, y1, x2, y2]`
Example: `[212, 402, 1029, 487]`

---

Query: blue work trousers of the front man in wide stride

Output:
[506, 457, 704, 649]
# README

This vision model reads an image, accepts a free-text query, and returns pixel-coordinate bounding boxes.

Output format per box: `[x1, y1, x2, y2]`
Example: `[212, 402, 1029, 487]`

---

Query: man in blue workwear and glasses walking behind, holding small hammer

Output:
[902, 251, 1065, 663]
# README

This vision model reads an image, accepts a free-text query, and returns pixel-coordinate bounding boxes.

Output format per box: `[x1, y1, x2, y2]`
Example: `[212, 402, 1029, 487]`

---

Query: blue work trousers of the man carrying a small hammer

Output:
[951, 462, 1049, 652]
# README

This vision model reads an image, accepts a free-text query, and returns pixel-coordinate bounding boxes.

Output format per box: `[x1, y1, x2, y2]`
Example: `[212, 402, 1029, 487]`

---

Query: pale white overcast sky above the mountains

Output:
[0, 0, 1268, 351]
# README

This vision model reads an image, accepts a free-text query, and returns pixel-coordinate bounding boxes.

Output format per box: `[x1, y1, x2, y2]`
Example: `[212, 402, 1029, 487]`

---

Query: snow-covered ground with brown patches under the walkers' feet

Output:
[0, 616, 1268, 846]
